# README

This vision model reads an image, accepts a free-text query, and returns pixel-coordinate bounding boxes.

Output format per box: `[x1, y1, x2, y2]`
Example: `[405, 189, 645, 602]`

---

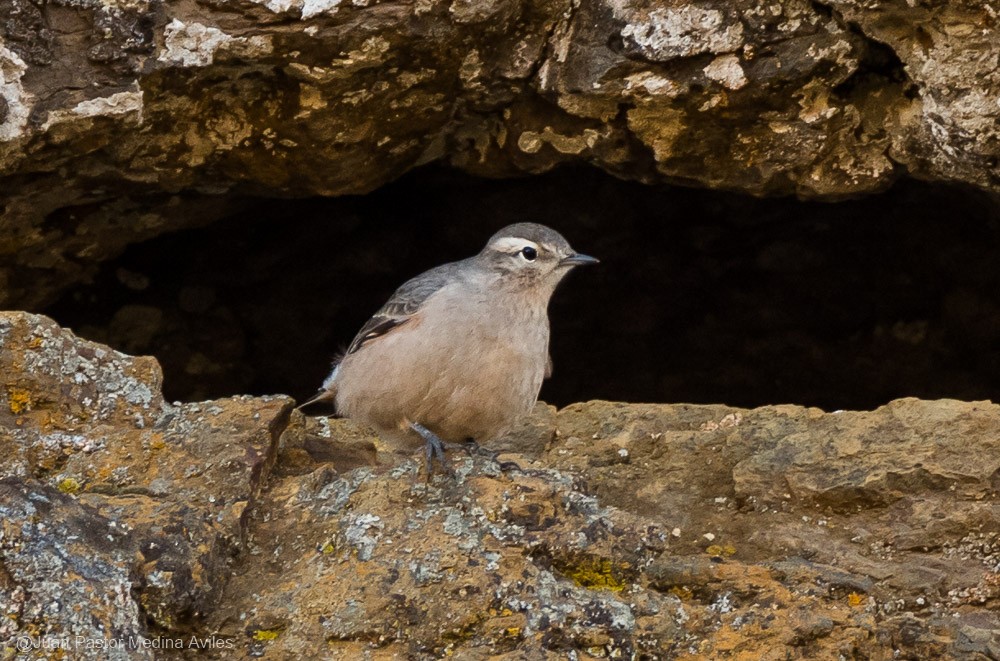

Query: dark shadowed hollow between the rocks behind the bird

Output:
[44, 168, 1000, 410]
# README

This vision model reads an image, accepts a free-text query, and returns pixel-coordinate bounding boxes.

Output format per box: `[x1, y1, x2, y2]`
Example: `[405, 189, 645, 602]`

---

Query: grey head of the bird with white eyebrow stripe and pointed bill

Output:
[477, 223, 598, 293]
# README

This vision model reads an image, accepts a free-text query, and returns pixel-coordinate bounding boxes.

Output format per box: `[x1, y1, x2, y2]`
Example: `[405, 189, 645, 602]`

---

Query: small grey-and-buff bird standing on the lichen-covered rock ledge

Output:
[299, 223, 598, 475]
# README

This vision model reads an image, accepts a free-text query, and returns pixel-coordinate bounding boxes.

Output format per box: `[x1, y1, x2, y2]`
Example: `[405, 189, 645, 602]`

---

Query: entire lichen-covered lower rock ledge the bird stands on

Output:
[0, 313, 1000, 659]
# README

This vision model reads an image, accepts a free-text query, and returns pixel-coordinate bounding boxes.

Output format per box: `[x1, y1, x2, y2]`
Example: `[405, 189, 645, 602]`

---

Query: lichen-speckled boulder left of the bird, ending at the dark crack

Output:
[0, 313, 291, 638]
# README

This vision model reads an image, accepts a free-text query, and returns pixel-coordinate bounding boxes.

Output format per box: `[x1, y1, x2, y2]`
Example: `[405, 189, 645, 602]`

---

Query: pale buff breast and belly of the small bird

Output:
[334, 296, 548, 449]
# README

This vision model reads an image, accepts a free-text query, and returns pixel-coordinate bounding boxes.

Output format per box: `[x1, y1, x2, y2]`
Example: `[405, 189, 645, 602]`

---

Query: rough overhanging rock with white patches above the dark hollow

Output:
[0, 0, 1000, 309]
